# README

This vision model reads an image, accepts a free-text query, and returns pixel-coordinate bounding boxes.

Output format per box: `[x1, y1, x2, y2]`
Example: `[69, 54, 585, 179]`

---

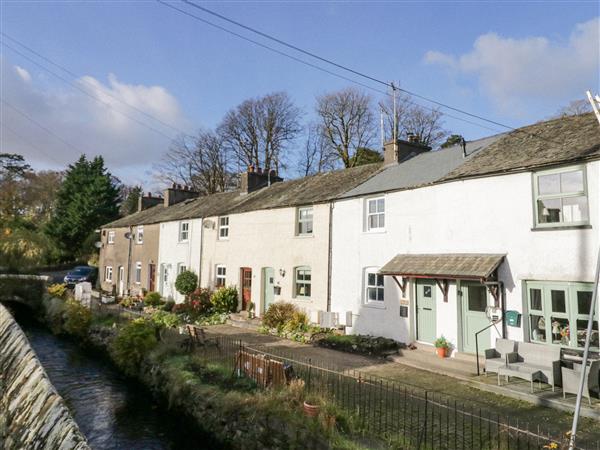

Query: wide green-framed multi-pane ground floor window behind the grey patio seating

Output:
[526, 281, 599, 348]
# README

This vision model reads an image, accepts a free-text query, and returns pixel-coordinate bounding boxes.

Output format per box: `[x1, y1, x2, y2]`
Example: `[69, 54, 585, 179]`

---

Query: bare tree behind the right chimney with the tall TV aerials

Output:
[379, 92, 450, 147]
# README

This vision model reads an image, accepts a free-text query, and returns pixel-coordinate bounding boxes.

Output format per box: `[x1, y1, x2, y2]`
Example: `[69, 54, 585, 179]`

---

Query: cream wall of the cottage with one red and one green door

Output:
[201, 204, 329, 321]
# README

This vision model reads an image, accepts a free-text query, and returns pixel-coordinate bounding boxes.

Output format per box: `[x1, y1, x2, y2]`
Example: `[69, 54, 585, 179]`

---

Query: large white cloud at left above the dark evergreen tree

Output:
[0, 58, 189, 182]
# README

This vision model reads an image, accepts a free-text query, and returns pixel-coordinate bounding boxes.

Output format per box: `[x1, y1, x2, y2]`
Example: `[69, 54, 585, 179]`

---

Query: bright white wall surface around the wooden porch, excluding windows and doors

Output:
[331, 162, 600, 348]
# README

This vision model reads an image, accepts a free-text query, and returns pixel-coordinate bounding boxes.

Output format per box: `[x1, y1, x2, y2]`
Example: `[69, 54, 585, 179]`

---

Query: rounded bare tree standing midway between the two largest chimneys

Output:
[316, 88, 376, 167]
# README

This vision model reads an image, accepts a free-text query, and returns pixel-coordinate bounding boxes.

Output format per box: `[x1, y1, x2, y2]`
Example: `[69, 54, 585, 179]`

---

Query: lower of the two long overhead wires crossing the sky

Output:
[156, 0, 500, 133]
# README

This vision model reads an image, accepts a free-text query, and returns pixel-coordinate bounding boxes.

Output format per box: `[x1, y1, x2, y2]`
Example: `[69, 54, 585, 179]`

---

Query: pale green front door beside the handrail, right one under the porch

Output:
[460, 282, 490, 353]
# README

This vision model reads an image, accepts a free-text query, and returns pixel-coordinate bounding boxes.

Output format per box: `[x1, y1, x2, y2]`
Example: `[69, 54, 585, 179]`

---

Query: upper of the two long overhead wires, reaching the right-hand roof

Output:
[175, 0, 564, 146]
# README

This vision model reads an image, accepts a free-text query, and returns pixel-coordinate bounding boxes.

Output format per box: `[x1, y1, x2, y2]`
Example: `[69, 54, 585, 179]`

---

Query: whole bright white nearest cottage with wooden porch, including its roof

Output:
[331, 114, 600, 352]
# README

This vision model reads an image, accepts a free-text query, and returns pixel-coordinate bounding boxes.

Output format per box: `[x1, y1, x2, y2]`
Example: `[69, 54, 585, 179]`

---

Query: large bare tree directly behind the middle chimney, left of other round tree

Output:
[218, 92, 302, 172]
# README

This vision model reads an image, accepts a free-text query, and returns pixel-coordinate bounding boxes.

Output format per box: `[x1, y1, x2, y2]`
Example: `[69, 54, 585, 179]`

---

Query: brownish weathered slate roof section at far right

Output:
[441, 113, 600, 181]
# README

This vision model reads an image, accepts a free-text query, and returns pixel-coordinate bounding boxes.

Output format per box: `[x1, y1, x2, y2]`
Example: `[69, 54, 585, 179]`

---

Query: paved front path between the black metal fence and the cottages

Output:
[205, 325, 600, 441]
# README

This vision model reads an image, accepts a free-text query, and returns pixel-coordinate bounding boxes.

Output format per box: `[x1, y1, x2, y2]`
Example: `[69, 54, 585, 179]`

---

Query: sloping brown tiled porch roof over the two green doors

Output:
[379, 253, 505, 279]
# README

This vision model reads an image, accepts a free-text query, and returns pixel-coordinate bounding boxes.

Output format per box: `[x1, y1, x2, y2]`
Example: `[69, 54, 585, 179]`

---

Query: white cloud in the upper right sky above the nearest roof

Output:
[424, 18, 600, 114]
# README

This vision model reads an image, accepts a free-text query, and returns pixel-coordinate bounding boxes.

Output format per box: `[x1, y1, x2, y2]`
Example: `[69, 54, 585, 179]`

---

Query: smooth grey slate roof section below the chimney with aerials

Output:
[340, 134, 503, 198]
